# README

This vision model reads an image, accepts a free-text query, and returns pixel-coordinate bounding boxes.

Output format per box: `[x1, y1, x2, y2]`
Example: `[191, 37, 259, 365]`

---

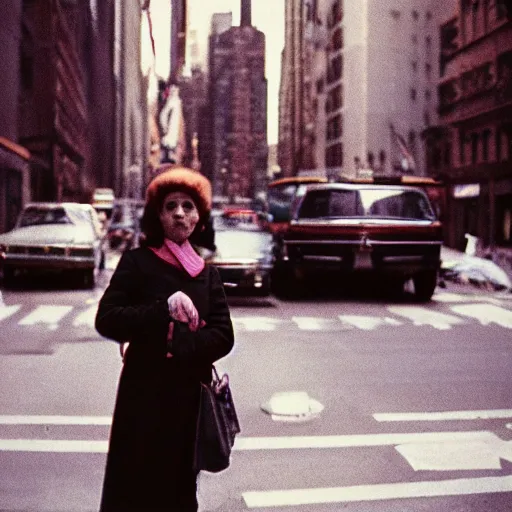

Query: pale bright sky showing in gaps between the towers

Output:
[146, 0, 285, 144]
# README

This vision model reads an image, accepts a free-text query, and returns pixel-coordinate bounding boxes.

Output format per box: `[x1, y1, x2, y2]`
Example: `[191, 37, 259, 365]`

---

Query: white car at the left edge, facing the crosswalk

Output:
[0, 203, 106, 288]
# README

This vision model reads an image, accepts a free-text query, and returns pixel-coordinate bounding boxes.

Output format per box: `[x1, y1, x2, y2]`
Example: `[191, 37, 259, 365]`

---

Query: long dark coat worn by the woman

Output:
[96, 248, 234, 512]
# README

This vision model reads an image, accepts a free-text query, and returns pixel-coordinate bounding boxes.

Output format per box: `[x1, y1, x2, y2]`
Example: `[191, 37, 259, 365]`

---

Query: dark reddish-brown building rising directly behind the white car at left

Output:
[18, 0, 88, 201]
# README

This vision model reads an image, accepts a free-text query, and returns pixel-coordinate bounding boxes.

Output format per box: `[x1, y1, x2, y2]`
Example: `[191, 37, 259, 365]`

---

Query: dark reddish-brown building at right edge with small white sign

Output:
[426, 0, 512, 249]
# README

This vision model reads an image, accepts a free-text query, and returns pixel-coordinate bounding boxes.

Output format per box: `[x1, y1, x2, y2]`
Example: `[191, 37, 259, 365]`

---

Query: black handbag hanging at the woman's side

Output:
[194, 365, 240, 473]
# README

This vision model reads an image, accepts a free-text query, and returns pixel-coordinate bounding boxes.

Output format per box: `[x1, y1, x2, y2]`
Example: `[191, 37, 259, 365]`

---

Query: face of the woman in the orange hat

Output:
[160, 192, 199, 245]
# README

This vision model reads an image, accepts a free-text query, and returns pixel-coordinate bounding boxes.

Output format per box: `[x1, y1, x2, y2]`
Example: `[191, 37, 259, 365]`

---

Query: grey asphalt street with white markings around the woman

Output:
[0, 264, 512, 512]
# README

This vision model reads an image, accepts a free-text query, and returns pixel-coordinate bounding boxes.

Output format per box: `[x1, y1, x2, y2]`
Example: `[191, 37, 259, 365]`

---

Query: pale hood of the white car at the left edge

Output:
[0, 224, 94, 245]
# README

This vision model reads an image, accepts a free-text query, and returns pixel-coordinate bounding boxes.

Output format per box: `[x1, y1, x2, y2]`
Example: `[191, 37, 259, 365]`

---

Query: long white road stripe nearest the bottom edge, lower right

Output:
[242, 476, 512, 508]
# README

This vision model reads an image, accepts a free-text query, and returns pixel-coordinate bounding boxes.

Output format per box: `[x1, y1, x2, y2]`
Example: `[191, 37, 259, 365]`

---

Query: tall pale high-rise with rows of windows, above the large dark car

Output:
[280, 0, 456, 176]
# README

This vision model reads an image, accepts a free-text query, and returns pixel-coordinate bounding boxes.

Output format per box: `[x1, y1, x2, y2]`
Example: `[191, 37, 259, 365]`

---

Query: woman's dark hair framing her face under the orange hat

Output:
[141, 184, 210, 247]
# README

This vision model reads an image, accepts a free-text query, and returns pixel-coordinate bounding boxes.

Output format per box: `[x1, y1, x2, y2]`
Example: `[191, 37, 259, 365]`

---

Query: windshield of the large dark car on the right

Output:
[299, 188, 435, 220]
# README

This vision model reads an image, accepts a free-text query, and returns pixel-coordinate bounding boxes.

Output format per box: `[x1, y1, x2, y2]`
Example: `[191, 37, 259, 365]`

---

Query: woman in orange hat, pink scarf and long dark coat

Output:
[96, 166, 234, 512]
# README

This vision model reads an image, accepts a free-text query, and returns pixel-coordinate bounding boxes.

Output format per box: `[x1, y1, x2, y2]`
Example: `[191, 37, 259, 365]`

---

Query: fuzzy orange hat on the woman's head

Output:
[146, 164, 212, 219]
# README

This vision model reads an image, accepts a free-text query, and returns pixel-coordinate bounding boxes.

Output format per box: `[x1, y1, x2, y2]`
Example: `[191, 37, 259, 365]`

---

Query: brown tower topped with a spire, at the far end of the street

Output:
[209, 0, 268, 198]
